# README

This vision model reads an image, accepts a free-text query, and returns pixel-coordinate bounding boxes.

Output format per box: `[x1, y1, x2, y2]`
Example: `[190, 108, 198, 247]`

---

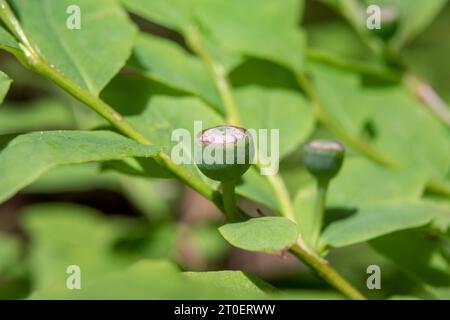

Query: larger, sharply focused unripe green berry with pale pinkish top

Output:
[196, 125, 255, 181]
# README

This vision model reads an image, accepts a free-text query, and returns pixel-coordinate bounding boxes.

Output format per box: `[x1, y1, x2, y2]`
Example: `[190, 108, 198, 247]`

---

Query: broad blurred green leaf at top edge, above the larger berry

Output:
[197, 0, 306, 73]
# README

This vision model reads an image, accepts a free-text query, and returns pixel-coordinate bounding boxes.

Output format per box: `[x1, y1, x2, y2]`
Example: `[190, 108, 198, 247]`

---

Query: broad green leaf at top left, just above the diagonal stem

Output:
[13, 0, 136, 95]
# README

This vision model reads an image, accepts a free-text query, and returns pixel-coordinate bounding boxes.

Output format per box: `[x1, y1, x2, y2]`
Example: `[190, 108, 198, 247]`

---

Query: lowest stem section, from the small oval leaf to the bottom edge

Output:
[289, 245, 366, 300]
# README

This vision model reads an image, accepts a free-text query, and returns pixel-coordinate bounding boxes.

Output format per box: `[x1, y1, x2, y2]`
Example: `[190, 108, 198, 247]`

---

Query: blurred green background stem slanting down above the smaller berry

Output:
[296, 74, 398, 168]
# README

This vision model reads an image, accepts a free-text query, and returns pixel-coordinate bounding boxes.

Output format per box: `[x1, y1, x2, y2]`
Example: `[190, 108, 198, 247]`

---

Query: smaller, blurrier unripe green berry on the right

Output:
[303, 140, 345, 183]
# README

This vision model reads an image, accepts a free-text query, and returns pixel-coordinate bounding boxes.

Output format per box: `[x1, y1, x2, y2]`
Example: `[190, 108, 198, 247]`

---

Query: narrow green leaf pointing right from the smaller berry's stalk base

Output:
[322, 202, 443, 247]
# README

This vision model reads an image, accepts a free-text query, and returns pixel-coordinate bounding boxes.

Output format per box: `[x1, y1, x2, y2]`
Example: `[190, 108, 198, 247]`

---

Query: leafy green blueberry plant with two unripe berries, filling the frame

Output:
[0, 0, 450, 299]
